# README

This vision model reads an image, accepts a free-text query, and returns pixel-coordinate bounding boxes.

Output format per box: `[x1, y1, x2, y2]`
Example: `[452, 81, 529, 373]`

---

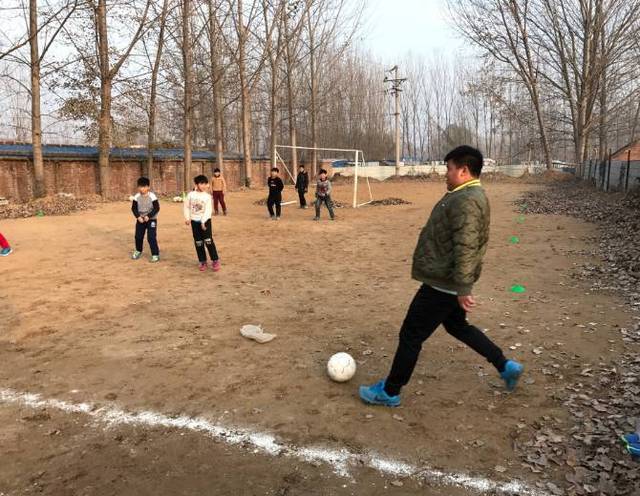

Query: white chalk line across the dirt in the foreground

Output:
[0, 389, 549, 496]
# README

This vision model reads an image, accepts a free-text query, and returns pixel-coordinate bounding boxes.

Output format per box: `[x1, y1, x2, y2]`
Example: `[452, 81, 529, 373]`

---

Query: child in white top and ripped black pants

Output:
[184, 175, 220, 272]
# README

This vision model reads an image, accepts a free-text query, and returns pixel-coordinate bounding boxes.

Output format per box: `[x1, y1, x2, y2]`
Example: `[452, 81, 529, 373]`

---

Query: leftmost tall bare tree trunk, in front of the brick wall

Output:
[29, 0, 45, 198]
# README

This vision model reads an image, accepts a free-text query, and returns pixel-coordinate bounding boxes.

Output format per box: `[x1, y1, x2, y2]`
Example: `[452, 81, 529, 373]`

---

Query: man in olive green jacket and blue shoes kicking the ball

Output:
[360, 146, 523, 406]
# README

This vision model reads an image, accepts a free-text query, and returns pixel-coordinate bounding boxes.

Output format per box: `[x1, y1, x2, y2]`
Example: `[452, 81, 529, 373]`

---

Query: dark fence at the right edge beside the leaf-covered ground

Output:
[580, 157, 640, 192]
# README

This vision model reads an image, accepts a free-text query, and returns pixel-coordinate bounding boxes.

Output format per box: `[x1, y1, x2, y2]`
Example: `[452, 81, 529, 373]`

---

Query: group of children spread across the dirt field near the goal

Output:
[127, 166, 335, 272]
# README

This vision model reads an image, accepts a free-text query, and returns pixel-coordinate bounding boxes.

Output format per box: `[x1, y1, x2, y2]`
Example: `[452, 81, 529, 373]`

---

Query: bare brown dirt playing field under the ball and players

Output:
[0, 183, 628, 496]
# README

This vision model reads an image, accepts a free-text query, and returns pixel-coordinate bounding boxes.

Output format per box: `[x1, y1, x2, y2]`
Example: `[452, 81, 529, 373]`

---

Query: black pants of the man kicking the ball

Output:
[385, 285, 507, 396]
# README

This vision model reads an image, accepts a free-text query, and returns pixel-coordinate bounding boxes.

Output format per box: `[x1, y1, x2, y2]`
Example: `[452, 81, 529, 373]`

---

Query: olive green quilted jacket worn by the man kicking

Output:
[411, 181, 490, 296]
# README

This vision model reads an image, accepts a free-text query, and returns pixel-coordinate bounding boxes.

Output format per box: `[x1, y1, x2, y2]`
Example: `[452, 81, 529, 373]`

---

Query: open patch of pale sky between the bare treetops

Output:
[361, 0, 462, 61]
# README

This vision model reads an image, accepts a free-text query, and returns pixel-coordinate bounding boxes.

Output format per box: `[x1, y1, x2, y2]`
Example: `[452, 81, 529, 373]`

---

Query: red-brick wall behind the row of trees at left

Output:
[0, 157, 270, 201]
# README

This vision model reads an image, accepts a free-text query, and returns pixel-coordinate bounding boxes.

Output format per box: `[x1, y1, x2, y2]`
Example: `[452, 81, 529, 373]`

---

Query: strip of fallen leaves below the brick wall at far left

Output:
[0, 193, 100, 219]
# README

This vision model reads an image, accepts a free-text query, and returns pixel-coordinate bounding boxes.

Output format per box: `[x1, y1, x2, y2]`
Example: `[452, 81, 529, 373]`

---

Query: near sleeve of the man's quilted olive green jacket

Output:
[449, 200, 482, 296]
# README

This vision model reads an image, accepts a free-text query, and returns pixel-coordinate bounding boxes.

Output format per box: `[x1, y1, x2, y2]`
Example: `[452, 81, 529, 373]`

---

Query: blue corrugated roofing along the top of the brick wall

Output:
[0, 144, 242, 160]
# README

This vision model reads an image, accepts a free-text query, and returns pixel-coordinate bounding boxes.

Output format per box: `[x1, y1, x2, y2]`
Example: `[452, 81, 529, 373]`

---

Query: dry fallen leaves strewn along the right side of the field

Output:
[517, 183, 640, 496]
